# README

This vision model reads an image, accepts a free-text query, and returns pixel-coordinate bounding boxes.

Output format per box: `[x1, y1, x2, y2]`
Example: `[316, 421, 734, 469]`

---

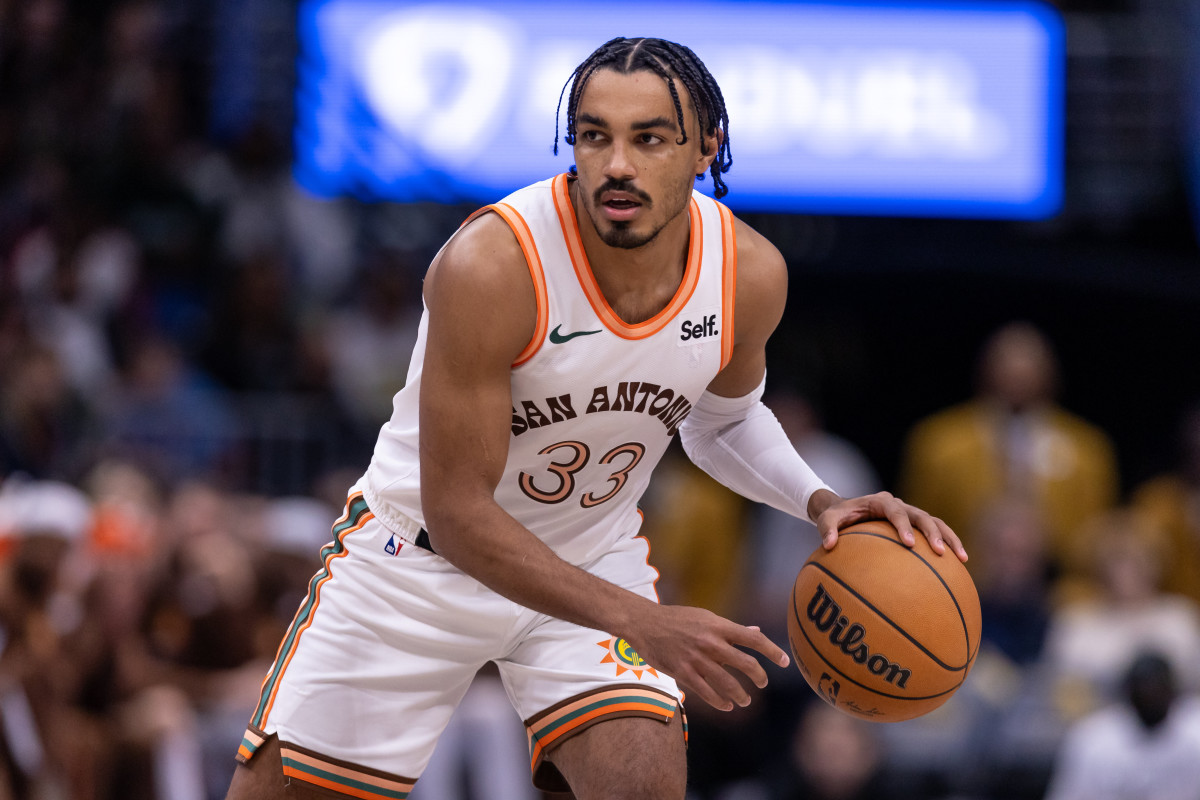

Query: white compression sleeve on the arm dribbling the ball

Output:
[679, 375, 832, 522]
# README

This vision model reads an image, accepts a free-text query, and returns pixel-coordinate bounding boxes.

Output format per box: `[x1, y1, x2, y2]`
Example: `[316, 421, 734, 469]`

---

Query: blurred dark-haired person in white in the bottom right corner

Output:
[1046, 652, 1200, 800]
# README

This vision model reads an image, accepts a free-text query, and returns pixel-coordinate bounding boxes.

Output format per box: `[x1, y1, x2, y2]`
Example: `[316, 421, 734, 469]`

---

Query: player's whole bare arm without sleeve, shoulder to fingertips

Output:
[420, 215, 787, 709]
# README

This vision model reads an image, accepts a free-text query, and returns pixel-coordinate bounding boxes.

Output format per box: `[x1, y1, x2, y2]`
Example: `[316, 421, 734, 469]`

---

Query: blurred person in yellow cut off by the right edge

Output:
[1132, 405, 1200, 602]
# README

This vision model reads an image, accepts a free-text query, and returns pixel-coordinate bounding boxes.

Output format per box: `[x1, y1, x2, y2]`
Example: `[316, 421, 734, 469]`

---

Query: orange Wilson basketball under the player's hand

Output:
[787, 521, 980, 722]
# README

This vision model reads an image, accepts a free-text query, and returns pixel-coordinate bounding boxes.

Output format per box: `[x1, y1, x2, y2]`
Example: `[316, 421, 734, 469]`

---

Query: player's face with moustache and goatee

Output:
[575, 70, 716, 249]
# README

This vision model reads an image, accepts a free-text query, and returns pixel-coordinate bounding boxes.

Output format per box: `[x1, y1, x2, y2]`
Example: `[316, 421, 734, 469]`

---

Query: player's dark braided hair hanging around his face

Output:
[554, 36, 733, 198]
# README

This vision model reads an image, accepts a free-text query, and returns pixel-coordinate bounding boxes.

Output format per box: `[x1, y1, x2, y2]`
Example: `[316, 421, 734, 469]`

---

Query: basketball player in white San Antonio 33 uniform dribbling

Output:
[228, 38, 966, 800]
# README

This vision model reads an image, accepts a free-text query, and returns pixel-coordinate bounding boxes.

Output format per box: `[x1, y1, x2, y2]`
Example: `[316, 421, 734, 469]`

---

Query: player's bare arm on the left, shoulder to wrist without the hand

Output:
[420, 215, 619, 627]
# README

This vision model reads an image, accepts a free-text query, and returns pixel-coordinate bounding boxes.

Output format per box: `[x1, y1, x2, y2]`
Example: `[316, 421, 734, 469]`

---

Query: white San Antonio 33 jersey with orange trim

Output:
[362, 174, 737, 565]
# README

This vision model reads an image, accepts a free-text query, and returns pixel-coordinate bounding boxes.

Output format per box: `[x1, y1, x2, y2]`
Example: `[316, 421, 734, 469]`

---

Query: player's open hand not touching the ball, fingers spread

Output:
[623, 606, 790, 711]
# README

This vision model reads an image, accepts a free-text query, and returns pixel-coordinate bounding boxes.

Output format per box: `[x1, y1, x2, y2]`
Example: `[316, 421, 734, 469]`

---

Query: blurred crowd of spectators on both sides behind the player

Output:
[0, 0, 1200, 800]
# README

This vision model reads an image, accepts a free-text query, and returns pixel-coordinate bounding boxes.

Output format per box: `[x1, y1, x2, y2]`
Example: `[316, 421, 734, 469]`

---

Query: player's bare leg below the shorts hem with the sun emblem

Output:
[546, 714, 688, 800]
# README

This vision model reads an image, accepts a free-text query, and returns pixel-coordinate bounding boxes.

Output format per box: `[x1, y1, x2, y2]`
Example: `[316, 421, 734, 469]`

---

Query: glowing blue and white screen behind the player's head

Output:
[294, 0, 1064, 218]
